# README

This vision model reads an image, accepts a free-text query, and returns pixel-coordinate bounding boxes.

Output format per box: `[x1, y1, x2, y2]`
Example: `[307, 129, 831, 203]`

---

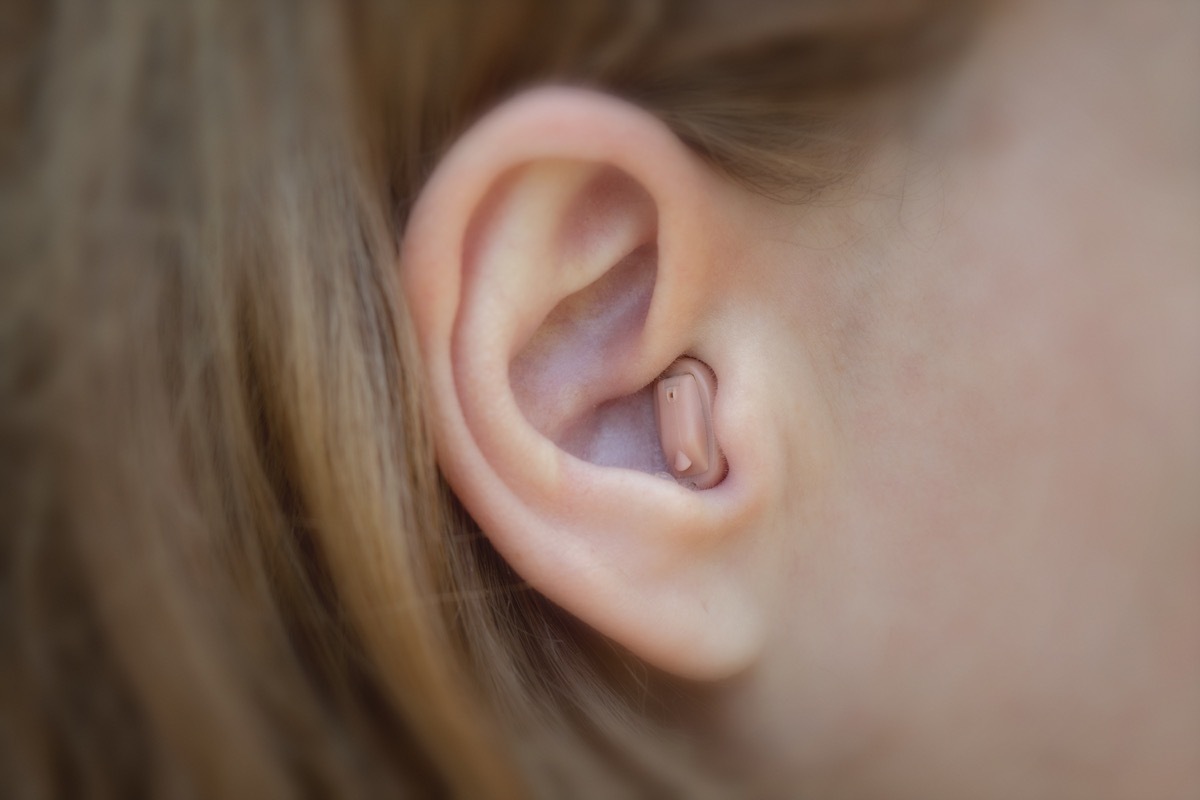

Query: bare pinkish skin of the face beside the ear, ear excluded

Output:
[724, 2, 1200, 798]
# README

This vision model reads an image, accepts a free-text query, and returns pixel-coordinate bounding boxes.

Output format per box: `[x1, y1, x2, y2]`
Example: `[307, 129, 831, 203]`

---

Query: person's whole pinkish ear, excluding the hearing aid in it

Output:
[401, 89, 763, 679]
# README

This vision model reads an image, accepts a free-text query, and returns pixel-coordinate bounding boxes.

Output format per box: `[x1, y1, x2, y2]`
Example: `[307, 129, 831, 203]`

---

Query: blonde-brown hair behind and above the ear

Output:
[0, 0, 964, 798]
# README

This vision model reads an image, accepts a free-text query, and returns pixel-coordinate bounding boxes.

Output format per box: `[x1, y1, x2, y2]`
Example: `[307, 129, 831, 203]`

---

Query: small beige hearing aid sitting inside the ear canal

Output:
[654, 357, 725, 489]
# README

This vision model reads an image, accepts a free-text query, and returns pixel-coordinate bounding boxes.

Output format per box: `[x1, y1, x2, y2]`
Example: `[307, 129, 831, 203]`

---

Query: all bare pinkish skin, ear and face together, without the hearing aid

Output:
[401, 0, 1200, 799]
